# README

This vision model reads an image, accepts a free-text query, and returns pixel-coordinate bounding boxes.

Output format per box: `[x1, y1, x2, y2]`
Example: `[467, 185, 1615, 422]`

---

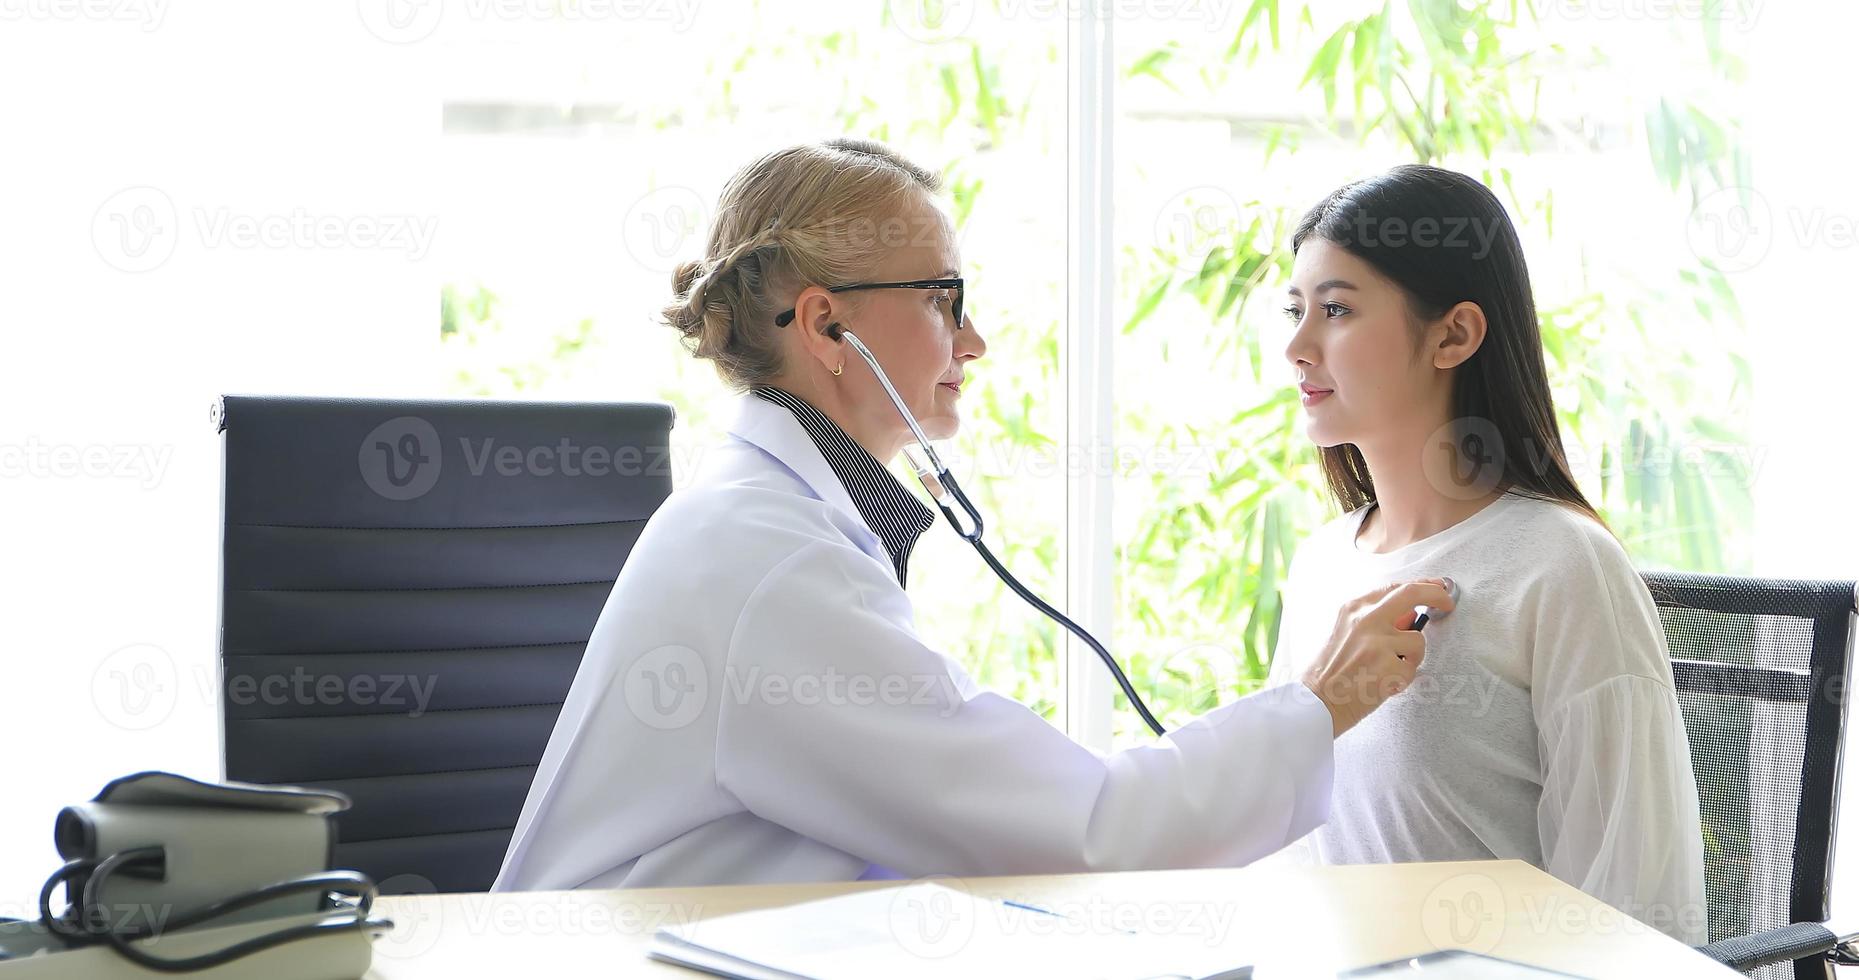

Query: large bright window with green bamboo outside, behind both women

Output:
[0, 0, 1859, 915]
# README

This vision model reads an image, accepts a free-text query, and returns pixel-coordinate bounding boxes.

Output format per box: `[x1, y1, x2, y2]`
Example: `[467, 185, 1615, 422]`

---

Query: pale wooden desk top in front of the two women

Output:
[368, 861, 1740, 980]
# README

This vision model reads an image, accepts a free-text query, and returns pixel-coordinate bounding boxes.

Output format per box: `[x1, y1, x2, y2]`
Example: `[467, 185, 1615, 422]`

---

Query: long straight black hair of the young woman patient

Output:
[1290, 164, 1604, 524]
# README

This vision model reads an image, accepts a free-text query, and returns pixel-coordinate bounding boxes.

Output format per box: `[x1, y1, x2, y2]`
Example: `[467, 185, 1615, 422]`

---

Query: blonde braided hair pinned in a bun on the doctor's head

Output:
[664, 139, 943, 389]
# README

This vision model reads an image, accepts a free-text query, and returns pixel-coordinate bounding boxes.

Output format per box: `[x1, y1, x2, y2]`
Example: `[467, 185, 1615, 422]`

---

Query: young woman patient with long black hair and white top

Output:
[1272, 166, 1705, 943]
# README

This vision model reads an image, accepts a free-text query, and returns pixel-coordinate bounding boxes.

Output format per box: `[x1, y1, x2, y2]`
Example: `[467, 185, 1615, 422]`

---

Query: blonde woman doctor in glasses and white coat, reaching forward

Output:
[494, 139, 1452, 891]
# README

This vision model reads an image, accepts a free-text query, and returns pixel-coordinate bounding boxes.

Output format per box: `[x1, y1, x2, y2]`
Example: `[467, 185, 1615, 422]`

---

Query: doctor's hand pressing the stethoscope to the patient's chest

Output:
[1301, 578, 1454, 736]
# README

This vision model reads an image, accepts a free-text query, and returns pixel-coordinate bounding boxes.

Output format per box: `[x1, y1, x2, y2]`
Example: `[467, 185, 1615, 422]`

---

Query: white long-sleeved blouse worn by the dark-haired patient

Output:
[1272, 495, 1707, 945]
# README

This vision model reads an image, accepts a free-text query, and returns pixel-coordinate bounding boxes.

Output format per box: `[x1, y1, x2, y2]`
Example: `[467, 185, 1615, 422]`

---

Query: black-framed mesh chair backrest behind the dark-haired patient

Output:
[1643, 573, 1855, 978]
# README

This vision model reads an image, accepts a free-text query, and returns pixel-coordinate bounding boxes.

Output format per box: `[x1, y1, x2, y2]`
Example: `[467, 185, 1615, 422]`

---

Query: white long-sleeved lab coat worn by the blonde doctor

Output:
[494, 396, 1333, 891]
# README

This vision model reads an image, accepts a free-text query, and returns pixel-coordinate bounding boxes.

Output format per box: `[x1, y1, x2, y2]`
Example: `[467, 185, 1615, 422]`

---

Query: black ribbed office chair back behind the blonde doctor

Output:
[214, 396, 673, 891]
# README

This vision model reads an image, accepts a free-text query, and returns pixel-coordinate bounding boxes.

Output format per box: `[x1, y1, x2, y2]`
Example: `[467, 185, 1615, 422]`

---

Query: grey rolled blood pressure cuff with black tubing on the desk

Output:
[54, 772, 349, 930]
